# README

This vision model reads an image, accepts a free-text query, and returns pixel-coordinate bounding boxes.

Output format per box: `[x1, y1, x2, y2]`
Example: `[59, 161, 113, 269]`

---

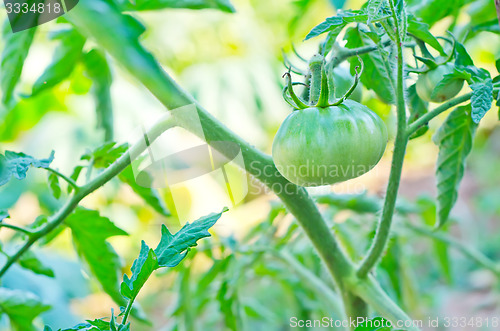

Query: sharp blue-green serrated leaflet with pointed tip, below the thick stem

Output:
[154, 208, 227, 267]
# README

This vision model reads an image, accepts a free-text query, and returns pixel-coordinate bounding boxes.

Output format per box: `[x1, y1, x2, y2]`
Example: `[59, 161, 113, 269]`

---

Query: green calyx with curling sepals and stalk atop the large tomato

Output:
[283, 54, 364, 110]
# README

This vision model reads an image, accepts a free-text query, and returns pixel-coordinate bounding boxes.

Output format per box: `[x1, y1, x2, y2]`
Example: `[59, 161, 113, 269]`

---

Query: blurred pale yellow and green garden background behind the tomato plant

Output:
[0, 0, 500, 330]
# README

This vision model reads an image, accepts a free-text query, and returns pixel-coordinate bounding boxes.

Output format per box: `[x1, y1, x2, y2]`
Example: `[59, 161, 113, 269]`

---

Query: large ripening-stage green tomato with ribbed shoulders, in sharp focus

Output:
[273, 100, 387, 186]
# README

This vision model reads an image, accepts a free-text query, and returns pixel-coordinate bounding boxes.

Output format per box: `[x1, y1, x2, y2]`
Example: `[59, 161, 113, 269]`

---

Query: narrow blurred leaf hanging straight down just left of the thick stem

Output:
[84, 49, 113, 141]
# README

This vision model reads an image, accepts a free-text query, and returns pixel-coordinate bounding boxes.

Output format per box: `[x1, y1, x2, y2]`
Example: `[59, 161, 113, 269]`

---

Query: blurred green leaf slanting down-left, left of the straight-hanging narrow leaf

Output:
[32, 29, 85, 95]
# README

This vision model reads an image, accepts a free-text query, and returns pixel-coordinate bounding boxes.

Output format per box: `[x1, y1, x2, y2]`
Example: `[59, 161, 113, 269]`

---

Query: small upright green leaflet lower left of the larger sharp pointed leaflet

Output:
[121, 241, 159, 300]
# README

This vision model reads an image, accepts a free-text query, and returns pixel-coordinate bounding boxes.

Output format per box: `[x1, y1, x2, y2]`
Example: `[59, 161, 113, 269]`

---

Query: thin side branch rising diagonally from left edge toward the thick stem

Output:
[0, 116, 176, 277]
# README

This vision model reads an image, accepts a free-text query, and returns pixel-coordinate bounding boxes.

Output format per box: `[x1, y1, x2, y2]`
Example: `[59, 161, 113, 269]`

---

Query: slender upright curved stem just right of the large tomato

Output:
[357, 0, 408, 278]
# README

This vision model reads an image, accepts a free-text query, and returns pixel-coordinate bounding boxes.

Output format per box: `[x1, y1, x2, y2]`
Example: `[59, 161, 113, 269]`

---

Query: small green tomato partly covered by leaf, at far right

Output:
[417, 63, 464, 103]
